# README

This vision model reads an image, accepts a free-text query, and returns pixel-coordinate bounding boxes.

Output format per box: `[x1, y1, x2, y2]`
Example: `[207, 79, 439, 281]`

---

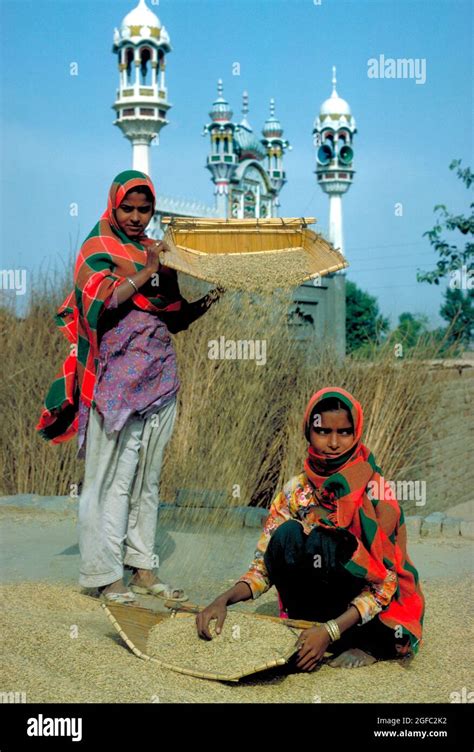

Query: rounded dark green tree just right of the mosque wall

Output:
[346, 280, 389, 353]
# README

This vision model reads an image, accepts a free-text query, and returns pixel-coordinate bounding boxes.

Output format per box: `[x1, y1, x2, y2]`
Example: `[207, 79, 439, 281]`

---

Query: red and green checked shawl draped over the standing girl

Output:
[36, 170, 181, 444]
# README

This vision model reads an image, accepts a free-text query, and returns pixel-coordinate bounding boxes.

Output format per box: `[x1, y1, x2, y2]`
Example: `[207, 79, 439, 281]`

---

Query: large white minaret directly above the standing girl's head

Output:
[112, 0, 171, 175]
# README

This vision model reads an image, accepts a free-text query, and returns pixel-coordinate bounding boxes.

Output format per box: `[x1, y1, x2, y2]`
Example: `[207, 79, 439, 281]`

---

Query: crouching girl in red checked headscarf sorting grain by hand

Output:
[196, 387, 424, 671]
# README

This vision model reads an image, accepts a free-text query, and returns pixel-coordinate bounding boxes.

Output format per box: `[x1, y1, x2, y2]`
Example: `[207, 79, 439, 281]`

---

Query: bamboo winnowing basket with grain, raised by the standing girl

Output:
[161, 217, 348, 292]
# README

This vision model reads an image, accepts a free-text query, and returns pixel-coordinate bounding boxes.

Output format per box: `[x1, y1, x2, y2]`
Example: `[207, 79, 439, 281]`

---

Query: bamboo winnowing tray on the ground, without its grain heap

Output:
[102, 603, 326, 682]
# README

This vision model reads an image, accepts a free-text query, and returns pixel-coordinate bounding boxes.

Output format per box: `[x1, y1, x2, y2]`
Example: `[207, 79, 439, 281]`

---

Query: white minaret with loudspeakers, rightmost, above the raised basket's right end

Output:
[313, 66, 357, 253]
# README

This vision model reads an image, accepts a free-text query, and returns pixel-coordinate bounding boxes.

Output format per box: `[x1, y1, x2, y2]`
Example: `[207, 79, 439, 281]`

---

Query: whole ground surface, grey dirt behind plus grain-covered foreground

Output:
[0, 507, 474, 703]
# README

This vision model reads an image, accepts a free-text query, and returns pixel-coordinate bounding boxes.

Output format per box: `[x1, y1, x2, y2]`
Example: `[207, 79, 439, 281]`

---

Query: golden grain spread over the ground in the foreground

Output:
[0, 578, 474, 703]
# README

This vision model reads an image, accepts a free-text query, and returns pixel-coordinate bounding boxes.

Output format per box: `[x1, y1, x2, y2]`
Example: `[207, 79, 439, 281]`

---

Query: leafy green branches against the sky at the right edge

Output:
[417, 159, 474, 285]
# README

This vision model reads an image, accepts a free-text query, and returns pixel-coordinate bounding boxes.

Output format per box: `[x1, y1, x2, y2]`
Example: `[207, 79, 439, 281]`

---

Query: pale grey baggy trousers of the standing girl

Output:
[78, 397, 176, 588]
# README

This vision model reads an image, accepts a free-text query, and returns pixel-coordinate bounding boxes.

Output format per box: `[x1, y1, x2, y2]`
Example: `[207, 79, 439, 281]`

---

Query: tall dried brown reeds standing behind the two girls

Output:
[0, 265, 460, 522]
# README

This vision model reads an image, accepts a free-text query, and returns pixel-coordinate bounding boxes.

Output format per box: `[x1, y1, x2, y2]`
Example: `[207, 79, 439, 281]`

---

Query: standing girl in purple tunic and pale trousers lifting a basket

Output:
[37, 170, 221, 603]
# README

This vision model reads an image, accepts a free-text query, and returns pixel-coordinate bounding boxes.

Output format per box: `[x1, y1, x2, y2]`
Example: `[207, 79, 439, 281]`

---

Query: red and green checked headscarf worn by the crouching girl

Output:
[303, 387, 425, 655]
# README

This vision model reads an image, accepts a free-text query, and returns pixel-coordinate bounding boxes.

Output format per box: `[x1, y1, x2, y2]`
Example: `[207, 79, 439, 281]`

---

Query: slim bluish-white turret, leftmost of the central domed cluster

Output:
[202, 79, 237, 217]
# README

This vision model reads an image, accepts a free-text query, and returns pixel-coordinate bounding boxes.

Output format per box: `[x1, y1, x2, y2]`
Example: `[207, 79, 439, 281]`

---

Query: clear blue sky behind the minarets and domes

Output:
[0, 0, 473, 325]
